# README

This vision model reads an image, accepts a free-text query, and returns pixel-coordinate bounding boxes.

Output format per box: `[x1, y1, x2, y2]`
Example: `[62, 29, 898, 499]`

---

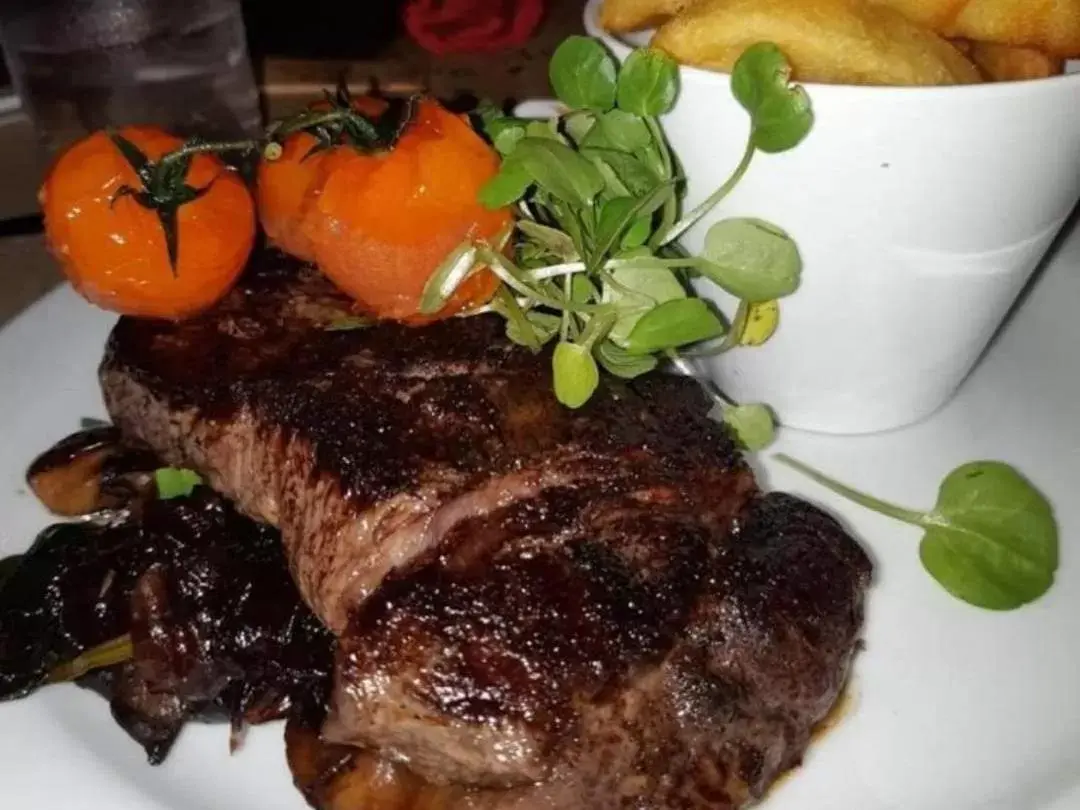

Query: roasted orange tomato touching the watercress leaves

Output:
[259, 99, 511, 323]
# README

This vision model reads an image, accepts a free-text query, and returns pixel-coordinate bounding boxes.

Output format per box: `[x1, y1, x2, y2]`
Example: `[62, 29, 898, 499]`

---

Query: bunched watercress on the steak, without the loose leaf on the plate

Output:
[421, 37, 812, 438]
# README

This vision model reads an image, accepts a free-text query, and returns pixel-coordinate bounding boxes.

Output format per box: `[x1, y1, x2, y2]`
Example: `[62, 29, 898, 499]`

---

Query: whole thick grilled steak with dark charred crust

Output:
[102, 254, 869, 809]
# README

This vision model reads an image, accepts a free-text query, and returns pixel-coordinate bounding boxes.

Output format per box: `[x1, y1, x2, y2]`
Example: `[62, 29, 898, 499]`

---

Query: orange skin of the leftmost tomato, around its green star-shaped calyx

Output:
[39, 126, 255, 319]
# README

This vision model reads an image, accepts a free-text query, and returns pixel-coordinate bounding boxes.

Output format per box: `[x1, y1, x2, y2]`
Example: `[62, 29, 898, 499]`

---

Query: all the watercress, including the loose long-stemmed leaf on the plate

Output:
[421, 37, 1057, 610]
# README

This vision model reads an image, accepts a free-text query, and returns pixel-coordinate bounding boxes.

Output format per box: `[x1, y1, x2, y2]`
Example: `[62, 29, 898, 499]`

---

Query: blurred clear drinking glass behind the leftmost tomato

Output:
[0, 0, 261, 152]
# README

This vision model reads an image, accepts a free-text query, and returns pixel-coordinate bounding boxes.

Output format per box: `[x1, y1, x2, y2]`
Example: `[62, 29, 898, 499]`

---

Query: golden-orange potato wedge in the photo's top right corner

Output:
[872, 0, 1080, 58]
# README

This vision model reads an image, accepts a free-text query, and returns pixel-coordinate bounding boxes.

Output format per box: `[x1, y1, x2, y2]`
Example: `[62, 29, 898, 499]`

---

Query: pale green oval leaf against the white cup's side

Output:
[699, 218, 802, 302]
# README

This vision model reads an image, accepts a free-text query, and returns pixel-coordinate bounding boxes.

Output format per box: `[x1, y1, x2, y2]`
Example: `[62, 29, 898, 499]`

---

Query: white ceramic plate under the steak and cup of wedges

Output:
[0, 219, 1080, 810]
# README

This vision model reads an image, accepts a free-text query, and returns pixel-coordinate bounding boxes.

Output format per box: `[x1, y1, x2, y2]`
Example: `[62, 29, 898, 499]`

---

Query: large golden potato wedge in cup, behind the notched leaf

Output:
[652, 0, 982, 85]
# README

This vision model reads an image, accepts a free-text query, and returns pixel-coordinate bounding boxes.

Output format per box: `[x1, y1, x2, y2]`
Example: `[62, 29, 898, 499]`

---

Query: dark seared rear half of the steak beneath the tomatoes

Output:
[102, 253, 748, 632]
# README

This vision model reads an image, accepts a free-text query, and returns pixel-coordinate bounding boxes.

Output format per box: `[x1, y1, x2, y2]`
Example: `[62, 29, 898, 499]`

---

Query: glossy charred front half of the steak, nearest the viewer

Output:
[323, 491, 869, 794]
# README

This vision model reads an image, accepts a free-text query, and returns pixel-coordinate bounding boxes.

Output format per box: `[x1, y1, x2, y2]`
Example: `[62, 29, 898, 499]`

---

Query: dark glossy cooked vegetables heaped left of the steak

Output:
[0, 429, 333, 764]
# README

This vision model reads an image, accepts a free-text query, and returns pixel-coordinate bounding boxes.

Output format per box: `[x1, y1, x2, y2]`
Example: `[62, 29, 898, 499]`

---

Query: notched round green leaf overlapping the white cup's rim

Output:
[731, 42, 813, 152]
